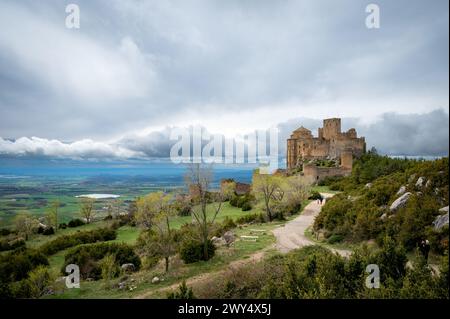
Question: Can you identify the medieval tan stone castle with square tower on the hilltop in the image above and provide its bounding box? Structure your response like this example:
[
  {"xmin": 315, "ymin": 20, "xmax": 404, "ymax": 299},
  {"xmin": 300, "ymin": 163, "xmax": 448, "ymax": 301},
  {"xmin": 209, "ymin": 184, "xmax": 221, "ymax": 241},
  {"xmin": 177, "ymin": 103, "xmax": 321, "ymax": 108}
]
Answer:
[{"xmin": 286, "ymin": 118, "xmax": 366, "ymax": 182}]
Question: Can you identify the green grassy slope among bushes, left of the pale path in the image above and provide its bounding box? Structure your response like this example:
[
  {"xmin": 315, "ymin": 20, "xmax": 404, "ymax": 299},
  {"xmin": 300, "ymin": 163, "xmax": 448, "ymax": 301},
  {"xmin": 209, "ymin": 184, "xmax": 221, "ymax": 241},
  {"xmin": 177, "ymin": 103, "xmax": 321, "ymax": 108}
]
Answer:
[{"xmin": 45, "ymin": 201, "xmax": 308, "ymax": 298}]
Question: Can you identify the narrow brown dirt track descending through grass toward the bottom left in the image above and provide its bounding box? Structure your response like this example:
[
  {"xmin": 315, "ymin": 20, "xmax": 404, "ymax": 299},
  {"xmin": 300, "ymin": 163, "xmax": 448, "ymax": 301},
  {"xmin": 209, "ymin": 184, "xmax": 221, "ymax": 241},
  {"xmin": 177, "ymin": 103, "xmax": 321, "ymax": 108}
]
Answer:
[{"xmin": 134, "ymin": 250, "xmax": 266, "ymax": 299}]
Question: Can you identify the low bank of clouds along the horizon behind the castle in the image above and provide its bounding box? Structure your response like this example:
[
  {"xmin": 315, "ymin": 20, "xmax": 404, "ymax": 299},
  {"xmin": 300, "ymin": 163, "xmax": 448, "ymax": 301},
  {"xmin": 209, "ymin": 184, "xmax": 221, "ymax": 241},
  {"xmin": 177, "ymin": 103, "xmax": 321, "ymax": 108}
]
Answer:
[{"xmin": 0, "ymin": 109, "xmax": 449, "ymax": 160}]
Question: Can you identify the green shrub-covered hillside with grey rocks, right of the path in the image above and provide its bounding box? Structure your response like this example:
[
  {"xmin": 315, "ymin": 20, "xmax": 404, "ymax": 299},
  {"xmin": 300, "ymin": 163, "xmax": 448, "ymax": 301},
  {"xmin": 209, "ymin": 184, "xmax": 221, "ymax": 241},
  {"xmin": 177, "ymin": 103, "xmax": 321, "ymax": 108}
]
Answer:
[{"xmin": 314, "ymin": 152, "xmax": 449, "ymax": 255}]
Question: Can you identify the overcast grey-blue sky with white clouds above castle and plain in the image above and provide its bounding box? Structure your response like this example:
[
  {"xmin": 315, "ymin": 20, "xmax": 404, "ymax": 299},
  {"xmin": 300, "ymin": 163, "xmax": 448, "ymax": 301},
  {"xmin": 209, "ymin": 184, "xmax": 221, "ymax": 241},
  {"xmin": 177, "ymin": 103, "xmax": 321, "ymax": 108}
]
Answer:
[{"xmin": 0, "ymin": 0, "xmax": 449, "ymax": 158}]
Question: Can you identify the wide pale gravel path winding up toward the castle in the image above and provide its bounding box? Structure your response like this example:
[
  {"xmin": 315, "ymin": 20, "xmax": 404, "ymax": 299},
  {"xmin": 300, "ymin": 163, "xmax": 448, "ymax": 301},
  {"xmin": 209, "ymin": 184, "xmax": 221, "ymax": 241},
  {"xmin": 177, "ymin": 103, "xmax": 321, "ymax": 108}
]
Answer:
[{"xmin": 272, "ymin": 193, "xmax": 351, "ymax": 257}]
